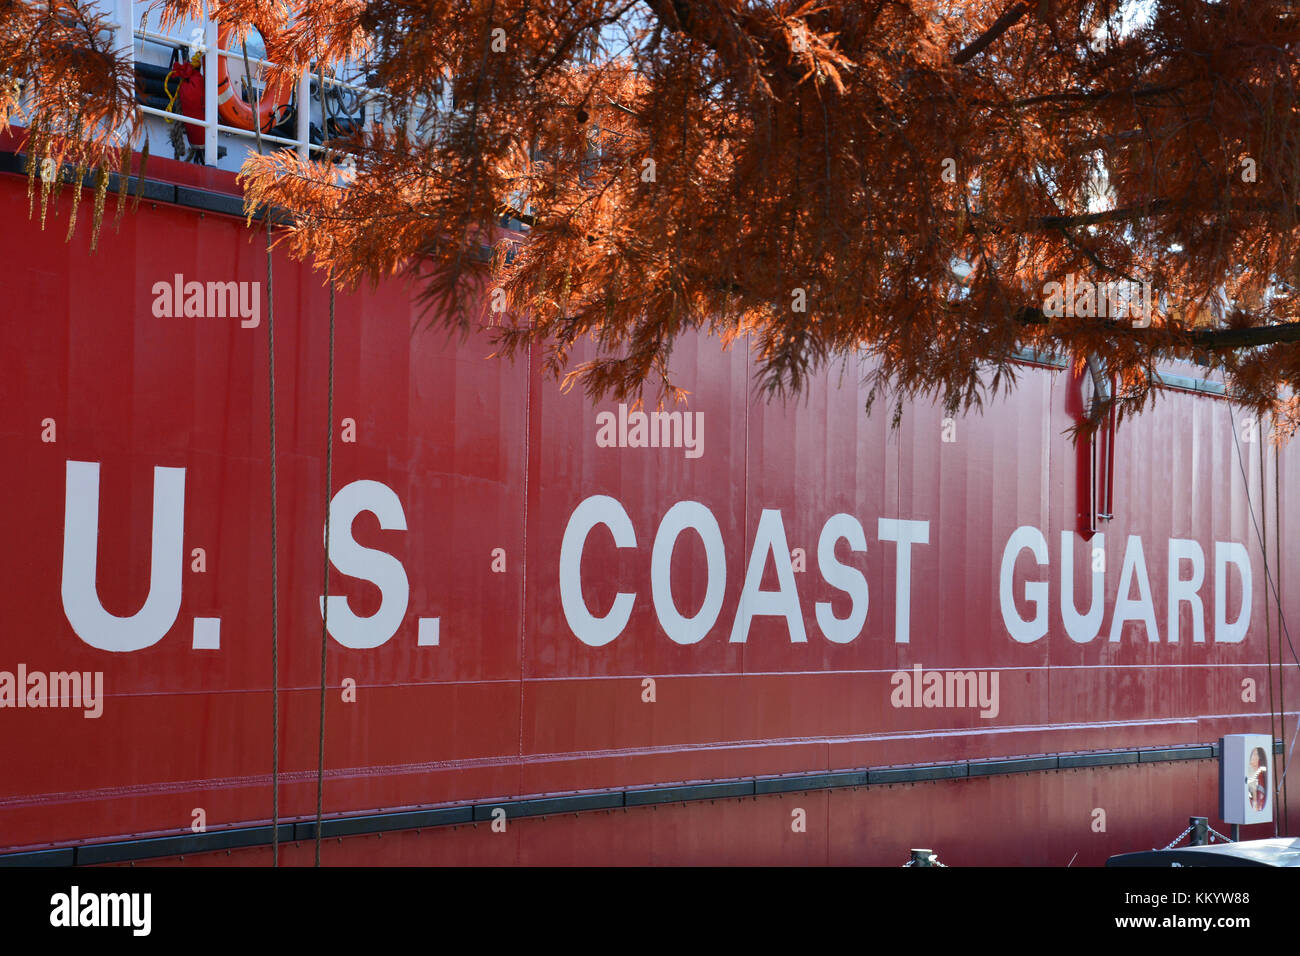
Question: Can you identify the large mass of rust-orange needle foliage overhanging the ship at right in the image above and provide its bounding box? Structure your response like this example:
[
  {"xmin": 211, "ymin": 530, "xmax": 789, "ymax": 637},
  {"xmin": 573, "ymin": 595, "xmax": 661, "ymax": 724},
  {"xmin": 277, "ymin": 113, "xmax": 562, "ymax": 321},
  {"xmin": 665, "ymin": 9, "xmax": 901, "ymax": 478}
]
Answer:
[{"xmin": 0, "ymin": 0, "xmax": 1300, "ymax": 426}]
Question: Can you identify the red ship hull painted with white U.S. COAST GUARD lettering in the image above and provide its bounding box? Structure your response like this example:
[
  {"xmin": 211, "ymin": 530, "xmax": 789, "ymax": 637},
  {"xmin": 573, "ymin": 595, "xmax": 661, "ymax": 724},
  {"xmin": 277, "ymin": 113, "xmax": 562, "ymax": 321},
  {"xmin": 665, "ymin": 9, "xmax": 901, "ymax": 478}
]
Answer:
[{"xmin": 0, "ymin": 151, "xmax": 1300, "ymax": 865}]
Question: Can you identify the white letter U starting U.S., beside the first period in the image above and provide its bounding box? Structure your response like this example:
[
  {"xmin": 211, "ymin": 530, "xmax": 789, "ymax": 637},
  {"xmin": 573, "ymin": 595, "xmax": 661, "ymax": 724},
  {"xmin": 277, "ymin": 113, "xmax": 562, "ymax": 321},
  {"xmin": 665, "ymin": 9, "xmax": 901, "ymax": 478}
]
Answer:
[{"xmin": 62, "ymin": 462, "xmax": 185, "ymax": 652}]
